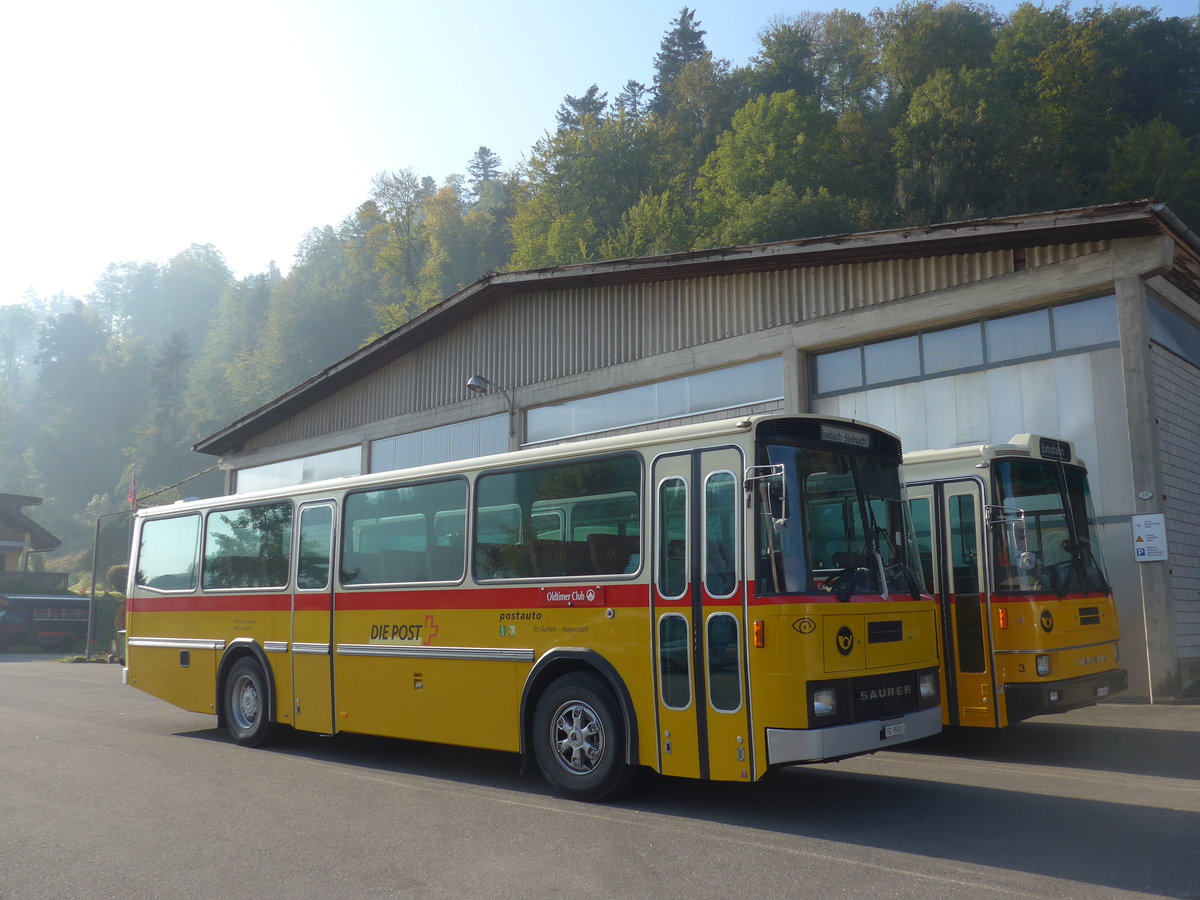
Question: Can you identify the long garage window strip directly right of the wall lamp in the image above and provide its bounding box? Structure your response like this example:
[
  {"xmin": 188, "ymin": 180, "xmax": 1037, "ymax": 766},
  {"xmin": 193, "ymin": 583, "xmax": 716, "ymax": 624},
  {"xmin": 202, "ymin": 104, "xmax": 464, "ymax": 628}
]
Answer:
[{"xmin": 526, "ymin": 356, "xmax": 784, "ymax": 444}]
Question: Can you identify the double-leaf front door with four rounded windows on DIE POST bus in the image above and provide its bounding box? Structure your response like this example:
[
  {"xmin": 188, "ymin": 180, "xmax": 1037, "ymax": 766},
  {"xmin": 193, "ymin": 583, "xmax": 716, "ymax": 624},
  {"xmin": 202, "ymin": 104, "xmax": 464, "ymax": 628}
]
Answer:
[{"xmin": 652, "ymin": 449, "xmax": 752, "ymax": 780}]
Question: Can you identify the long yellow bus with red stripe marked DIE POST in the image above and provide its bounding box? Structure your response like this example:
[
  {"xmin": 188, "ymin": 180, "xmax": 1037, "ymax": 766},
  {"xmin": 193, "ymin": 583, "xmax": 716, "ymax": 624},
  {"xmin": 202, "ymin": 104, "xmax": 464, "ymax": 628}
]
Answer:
[{"xmin": 125, "ymin": 416, "xmax": 942, "ymax": 799}]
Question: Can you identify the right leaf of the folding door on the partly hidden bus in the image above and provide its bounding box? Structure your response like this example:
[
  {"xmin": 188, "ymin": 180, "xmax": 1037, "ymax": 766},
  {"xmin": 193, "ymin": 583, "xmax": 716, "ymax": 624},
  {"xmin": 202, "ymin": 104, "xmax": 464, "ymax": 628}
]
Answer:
[{"xmin": 942, "ymin": 481, "xmax": 1000, "ymax": 726}]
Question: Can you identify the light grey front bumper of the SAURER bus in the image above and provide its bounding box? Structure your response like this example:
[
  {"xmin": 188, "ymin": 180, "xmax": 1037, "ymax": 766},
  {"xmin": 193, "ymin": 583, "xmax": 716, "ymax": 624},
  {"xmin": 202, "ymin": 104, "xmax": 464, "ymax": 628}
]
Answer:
[{"xmin": 767, "ymin": 707, "xmax": 942, "ymax": 766}]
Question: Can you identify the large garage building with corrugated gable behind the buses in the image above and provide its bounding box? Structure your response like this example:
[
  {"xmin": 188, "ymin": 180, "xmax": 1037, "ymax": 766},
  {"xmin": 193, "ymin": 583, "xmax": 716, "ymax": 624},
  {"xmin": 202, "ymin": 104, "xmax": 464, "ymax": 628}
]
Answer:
[{"xmin": 194, "ymin": 200, "xmax": 1200, "ymax": 701}]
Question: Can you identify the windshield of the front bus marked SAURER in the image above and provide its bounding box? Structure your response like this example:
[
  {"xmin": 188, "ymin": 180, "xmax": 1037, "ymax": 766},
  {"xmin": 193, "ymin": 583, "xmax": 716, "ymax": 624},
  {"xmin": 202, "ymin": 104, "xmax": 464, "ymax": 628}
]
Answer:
[{"xmin": 756, "ymin": 444, "xmax": 924, "ymax": 601}]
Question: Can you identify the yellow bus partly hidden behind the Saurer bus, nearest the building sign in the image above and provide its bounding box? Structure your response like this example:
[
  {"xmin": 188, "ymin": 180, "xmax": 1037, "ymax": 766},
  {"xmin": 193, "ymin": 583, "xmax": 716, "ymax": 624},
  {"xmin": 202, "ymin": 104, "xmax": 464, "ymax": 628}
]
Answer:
[{"xmin": 904, "ymin": 434, "xmax": 1128, "ymax": 728}]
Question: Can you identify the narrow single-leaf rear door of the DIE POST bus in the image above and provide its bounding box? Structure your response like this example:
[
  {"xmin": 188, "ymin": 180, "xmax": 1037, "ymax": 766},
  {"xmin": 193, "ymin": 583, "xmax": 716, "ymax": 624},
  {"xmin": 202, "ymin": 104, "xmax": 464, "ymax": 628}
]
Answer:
[{"xmin": 280, "ymin": 503, "xmax": 335, "ymax": 734}]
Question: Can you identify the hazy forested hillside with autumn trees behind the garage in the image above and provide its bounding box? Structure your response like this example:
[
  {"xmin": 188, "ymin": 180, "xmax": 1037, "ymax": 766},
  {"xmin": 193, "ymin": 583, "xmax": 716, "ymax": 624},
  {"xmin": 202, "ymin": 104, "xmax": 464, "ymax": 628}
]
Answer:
[{"xmin": 0, "ymin": 0, "xmax": 1200, "ymax": 571}]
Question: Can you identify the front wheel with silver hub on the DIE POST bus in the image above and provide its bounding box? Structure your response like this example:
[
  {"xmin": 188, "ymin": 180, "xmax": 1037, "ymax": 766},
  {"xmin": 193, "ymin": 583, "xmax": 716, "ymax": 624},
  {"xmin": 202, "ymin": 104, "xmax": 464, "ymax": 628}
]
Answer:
[{"xmin": 532, "ymin": 672, "xmax": 634, "ymax": 800}]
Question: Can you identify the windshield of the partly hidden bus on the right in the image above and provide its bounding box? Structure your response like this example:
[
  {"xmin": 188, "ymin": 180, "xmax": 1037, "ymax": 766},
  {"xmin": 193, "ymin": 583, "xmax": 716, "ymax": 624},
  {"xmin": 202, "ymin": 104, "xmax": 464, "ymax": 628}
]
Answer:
[{"xmin": 988, "ymin": 460, "xmax": 1109, "ymax": 595}]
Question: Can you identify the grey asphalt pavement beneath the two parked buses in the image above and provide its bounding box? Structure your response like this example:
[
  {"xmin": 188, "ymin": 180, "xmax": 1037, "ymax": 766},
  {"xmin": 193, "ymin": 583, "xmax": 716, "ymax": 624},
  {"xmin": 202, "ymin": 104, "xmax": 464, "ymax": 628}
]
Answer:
[{"xmin": 0, "ymin": 654, "xmax": 1200, "ymax": 900}]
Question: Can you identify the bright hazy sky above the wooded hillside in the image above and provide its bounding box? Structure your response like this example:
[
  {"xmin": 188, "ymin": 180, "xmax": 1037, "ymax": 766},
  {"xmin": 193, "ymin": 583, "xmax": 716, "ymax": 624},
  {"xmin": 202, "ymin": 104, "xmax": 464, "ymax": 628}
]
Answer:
[{"xmin": 0, "ymin": 0, "xmax": 1196, "ymax": 304}]
